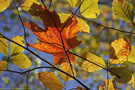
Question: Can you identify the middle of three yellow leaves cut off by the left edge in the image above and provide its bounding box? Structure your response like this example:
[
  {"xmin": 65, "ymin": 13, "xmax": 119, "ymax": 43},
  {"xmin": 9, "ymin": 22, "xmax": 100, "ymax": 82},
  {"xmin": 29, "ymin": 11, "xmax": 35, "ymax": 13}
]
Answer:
[{"xmin": 0, "ymin": 36, "xmax": 9, "ymax": 56}]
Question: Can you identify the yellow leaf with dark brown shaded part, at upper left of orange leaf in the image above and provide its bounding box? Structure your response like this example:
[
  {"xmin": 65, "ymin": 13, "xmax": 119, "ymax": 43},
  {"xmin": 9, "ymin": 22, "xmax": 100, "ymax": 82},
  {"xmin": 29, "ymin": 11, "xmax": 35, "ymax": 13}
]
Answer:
[{"xmin": 21, "ymin": 0, "xmax": 42, "ymax": 16}]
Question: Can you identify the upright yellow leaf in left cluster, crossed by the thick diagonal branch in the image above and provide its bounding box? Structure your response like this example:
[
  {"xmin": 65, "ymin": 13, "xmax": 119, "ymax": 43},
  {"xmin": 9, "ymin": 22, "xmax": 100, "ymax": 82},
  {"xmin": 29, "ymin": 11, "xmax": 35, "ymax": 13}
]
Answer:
[{"xmin": 10, "ymin": 36, "xmax": 25, "ymax": 56}]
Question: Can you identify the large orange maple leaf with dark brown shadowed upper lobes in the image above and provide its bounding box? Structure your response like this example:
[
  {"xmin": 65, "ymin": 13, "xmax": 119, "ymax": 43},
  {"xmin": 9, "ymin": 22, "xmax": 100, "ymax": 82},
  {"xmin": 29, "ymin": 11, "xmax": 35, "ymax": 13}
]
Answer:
[{"xmin": 23, "ymin": 3, "xmax": 81, "ymax": 65}]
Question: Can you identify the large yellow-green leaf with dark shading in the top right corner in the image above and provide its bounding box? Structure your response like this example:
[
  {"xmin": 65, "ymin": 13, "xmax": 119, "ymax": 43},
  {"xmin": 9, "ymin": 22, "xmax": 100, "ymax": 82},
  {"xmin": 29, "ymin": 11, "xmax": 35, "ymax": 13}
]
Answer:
[{"xmin": 112, "ymin": 0, "xmax": 134, "ymax": 22}]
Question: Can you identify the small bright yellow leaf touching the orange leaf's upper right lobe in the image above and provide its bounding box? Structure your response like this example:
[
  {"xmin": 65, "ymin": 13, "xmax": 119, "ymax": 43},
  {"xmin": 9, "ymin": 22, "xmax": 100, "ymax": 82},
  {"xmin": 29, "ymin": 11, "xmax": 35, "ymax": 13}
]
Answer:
[{"xmin": 77, "ymin": 17, "xmax": 90, "ymax": 33}]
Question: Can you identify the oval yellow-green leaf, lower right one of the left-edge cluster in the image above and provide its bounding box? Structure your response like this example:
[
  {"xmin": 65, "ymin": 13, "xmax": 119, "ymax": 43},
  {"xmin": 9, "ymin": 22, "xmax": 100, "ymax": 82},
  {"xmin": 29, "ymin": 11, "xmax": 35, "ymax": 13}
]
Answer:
[{"xmin": 11, "ymin": 54, "xmax": 32, "ymax": 69}]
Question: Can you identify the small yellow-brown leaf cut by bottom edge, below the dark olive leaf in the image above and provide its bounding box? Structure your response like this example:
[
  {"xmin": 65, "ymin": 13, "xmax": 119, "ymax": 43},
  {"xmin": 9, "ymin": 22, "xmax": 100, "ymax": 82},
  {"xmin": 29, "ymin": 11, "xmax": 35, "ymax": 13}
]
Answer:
[{"xmin": 104, "ymin": 79, "xmax": 117, "ymax": 90}]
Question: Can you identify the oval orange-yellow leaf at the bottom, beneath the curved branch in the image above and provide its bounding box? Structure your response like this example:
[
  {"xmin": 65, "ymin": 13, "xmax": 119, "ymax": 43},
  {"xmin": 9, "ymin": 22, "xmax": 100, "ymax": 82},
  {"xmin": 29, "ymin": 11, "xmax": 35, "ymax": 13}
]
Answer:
[{"xmin": 38, "ymin": 71, "xmax": 63, "ymax": 90}]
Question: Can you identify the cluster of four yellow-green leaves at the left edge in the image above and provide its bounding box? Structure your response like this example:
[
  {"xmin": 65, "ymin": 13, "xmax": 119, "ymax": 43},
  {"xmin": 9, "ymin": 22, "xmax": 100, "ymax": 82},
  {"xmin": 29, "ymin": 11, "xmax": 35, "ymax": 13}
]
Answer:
[{"xmin": 0, "ymin": 36, "xmax": 32, "ymax": 73}]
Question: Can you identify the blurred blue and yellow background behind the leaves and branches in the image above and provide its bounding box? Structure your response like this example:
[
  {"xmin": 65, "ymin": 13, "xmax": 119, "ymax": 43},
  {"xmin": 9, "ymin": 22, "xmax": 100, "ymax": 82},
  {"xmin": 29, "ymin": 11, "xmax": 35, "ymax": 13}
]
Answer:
[{"xmin": 0, "ymin": 0, "xmax": 135, "ymax": 90}]
